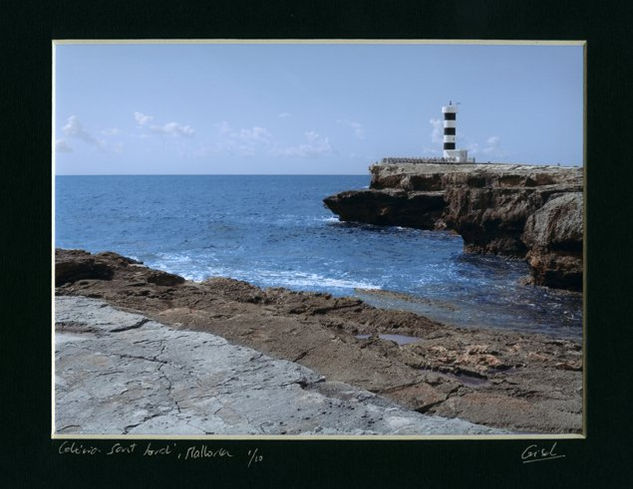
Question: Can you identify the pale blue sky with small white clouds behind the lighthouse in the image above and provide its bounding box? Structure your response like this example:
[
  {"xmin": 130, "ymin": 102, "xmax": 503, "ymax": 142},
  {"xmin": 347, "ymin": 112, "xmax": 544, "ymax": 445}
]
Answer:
[{"xmin": 54, "ymin": 43, "xmax": 583, "ymax": 175}]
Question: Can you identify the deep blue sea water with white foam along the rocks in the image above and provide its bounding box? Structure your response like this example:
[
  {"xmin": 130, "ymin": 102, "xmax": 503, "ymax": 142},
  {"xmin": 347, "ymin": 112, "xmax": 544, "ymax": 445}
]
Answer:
[{"xmin": 55, "ymin": 176, "xmax": 582, "ymax": 337}]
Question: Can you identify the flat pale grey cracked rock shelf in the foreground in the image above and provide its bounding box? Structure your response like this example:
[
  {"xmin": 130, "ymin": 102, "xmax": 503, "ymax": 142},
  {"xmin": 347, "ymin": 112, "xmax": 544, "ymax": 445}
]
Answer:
[{"xmin": 55, "ymin": 297, "xmax": 504, "ymax": 435}]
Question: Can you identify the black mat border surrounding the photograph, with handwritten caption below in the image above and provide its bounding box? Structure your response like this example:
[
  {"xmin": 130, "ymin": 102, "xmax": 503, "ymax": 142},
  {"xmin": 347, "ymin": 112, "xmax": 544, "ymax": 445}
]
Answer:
[{"xmin": 0, "ymin": 1, "xmax": 633, "ymax": 488}]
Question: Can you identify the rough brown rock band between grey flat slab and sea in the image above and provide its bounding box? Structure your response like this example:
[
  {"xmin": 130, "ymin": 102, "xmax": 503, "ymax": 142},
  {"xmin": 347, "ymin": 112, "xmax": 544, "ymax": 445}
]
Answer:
[{"xmin": 55, "ymin": 250, "xmax": 583, "ymax": 433}]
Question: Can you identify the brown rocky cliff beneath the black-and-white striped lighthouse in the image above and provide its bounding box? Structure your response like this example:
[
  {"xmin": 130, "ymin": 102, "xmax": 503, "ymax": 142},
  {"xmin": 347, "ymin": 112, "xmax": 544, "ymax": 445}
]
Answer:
[{"xmin": 324, "ymin": 163, "xmax": 583, "ymax": 290}]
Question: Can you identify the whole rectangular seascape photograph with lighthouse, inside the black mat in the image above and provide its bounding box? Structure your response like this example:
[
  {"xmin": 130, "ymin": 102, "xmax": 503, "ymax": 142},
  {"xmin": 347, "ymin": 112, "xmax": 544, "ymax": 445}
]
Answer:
[{"xmin": 51, "ymin": 40, "xmax": 585, "ymax": 439}]
